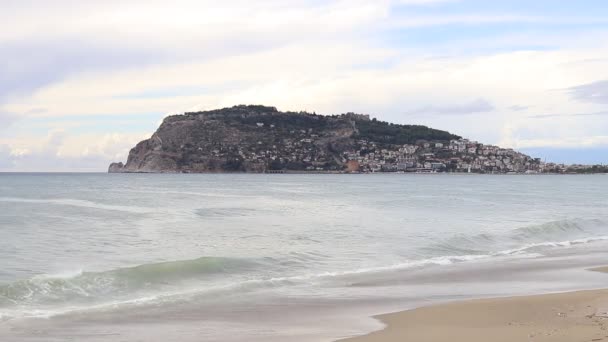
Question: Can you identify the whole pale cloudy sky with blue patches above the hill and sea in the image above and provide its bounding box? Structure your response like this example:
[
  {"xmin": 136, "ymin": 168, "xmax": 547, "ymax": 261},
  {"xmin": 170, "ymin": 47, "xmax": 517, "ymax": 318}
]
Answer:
[{"xmin": 0, "ymin": 0, "xmax": 608, "ymax": 172}]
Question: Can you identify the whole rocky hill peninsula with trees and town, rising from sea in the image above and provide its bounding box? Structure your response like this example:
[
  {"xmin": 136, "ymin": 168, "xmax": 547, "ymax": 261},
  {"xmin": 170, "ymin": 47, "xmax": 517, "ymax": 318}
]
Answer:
[{"xmin": 108, "ymin": 105, "xmax": 544, "ymax": 173}]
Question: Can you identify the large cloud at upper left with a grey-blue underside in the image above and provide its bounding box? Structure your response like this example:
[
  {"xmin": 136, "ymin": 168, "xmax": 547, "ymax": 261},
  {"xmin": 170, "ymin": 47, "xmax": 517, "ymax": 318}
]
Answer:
[{"xmin": 0, "ymin": 0, "xmax": 390, "ymax": 111}]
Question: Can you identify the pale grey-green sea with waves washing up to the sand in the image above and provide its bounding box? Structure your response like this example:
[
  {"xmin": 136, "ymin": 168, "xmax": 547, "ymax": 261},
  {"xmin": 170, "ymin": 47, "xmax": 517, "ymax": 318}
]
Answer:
[{"xmin": 0, "ymin": 173, "xmax": 608, "ymax": 342}]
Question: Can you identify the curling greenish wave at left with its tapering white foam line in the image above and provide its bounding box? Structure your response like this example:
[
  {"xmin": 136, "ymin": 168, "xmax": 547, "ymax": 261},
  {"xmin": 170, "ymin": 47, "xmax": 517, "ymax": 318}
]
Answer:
[{"xmin": 0, "ymin": 255, "xmax": 489, "ymax": 321}]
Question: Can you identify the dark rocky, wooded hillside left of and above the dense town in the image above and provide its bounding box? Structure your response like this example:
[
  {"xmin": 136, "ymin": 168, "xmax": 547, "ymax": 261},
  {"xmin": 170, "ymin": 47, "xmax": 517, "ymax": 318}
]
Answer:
[{"xmin": 108, "ymin": 106, "xmax": 459, "ymax": 173}]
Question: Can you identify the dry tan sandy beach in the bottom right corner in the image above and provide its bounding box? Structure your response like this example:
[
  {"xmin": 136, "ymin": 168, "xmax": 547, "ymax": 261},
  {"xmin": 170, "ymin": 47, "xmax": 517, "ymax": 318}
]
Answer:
[{"xmin": 342, "ymin": 267, "xmax": 608, "ymax": 342}]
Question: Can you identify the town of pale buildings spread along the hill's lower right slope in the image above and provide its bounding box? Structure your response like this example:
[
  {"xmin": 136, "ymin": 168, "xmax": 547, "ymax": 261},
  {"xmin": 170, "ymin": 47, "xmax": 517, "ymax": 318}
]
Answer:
[{"xmin": 228, "ymin": 122, "xmax": 608, "ymax": 174}]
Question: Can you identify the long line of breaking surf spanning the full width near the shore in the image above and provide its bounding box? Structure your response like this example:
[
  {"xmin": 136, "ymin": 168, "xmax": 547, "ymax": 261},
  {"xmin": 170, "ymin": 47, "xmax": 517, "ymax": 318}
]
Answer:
[{"xmin": 0, "ymin": 219, "xmax": 608, "ymax": 320}]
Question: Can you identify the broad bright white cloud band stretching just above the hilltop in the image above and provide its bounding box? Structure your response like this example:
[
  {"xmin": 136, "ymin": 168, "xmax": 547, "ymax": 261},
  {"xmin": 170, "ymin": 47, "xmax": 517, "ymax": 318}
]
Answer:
[{"xmin": 8, "ymin": 43, "xmax": 608, "ymax": 154}]
